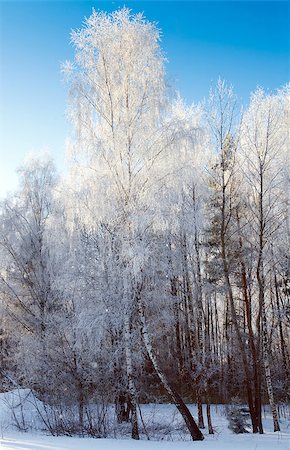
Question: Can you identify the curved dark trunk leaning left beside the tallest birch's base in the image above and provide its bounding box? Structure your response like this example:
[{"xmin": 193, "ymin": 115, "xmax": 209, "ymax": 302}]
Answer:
[{"xmin": 137, "ymin": 294, "xmax": 204, "ymax": 441}]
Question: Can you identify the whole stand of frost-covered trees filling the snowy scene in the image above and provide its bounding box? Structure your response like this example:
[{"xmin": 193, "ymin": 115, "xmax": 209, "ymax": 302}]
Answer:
[{"xmin": 0, "ymin": 8, "xmax": 290, "ymax": 440}]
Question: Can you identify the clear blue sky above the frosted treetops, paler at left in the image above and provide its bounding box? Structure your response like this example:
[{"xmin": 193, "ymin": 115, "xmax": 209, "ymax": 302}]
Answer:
[{"xmin": 0, "ymin": 0, "xmax": 289, "ymax": 197}]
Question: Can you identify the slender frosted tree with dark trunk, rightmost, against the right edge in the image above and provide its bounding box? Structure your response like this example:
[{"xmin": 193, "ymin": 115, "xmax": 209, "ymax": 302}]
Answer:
[{"xmin": 240, "ymin": 89, "xmax": 288, "ymax": 431}]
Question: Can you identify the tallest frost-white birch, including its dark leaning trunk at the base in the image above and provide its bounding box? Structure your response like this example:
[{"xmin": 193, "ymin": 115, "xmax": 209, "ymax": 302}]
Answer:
[{"xmin": 62, "ymin": 8, "xmax": 202, "ymax": 439}]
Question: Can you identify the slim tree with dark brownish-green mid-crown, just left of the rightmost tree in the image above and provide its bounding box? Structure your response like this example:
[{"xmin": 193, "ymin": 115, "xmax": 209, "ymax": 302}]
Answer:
[{"xmin": 204, "ymin": 80, "xmax": 262, "ymax": 432}]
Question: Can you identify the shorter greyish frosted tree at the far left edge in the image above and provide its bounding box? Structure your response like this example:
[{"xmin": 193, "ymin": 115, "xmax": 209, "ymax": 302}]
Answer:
[{"xmin": 0, "ymin": 158, "xmax": 57, "ymax": 391}]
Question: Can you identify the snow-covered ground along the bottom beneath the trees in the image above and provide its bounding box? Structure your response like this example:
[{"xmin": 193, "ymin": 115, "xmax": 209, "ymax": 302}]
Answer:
[{"xmin": 0, "ymin": 391, "xmax": 290, "ymax": 450}]
